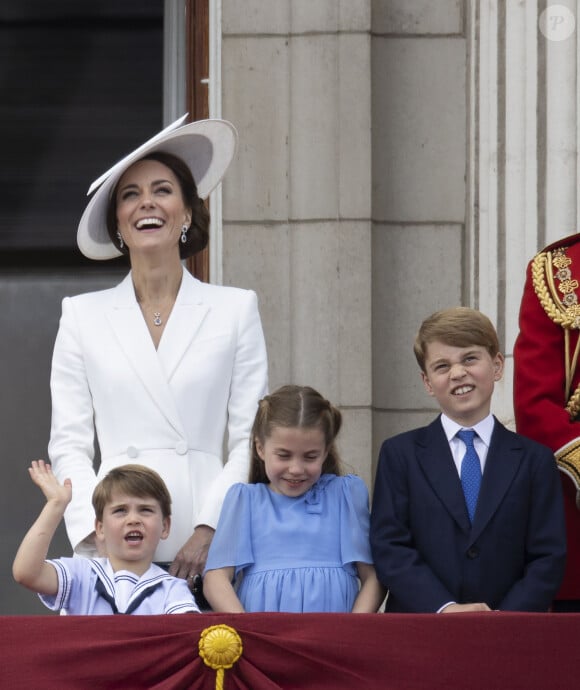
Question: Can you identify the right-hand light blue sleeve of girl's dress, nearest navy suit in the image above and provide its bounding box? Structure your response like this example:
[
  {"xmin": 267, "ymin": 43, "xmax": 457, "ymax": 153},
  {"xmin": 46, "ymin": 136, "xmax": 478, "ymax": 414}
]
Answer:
[{"xmin": 339, "ymin": 474, "xmax": 373, "ymax": 565}]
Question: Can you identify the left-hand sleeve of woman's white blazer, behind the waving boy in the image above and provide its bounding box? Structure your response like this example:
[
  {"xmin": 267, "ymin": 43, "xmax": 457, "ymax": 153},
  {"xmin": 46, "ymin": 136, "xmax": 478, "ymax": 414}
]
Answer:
[{"xmin": 48, "ymin": 297, "xmax": 96, "ymax": 555}]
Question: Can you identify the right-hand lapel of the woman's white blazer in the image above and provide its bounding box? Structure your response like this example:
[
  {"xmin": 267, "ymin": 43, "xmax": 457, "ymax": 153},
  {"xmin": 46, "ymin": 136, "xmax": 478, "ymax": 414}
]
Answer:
[{"xmin": 157, "ymin": 269, "xmax": 209, "ymax": 381}]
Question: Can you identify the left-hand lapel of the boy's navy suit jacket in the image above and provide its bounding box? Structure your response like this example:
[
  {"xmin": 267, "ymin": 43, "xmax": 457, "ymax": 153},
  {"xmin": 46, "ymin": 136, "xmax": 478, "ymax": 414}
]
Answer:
[{"xmin": 416, "ymin": 417, "xmax": 471, "ymax": 532}]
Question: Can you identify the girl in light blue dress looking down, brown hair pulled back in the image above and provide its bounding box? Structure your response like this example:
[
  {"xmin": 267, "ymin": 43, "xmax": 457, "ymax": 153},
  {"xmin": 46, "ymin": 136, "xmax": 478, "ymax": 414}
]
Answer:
[{"xmin": 204, "ymin": 386, "xmax": 384, "ymax": 613}]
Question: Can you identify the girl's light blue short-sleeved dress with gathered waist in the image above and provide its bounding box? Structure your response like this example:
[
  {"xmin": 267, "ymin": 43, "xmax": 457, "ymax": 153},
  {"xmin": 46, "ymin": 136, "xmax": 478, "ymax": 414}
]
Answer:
[{"xmin": 206, "ymin": 474, "xmax": 372, "ymax": 613}]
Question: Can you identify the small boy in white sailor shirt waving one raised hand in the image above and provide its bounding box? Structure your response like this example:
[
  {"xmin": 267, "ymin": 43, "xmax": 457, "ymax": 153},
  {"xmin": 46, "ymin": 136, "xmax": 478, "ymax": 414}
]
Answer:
[{"xmin": 12, "ymin": 460, "xmax": 199, "ymax": 615}]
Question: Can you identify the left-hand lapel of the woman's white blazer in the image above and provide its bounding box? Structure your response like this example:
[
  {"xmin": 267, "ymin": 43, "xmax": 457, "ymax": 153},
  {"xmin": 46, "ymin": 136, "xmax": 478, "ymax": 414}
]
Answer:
[{"xmin": 106, "ymin": 273, "xmax": 184, "ymax": 435}]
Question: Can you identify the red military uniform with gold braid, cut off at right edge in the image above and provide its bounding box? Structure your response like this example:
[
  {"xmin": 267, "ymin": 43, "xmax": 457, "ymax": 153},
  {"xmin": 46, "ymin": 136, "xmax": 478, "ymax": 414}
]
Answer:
[{"xmin": 514, "ymin": 234, "xmax": 580, "ymax": 600}]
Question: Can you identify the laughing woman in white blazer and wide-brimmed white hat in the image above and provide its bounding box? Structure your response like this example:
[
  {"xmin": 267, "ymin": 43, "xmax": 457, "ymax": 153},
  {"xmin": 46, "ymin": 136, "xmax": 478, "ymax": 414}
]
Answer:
[{"xmin": 49, "ymin": 118, "xmax": 267, "ymax": 592}]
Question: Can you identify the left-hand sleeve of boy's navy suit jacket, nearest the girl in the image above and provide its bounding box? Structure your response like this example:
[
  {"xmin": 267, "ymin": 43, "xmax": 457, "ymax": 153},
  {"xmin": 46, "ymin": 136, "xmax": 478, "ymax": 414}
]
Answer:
[{"xmin": 370, "ymin": 439, "xmax": 455, "ymax": 613}]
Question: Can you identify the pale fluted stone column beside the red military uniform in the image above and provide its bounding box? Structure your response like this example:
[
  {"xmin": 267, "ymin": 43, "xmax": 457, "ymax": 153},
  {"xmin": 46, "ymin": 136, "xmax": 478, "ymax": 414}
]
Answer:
[{"xmin": 466, "ymin": 0, "xmax": 578, "ymax": 425}]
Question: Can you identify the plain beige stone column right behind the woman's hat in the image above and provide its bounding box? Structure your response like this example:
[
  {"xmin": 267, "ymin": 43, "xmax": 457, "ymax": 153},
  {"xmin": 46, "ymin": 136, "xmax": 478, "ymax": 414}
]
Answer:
[{"xmin": 222, "ymin": 0, "xmax": 372, "ymax": 484}]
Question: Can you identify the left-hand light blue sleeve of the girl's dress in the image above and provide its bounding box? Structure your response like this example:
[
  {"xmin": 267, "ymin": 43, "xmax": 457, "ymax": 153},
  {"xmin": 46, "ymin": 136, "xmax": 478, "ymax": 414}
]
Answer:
[{"xmin": 205, "ymin": 484, "xmax": 258, "ymax": 576}]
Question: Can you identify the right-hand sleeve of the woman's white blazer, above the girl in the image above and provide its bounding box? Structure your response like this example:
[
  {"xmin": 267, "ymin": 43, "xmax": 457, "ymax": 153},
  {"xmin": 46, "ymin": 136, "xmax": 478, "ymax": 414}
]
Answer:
[{"xmin": 198, "ymin": 290, "xmax": 268, "ymax": 528}]
